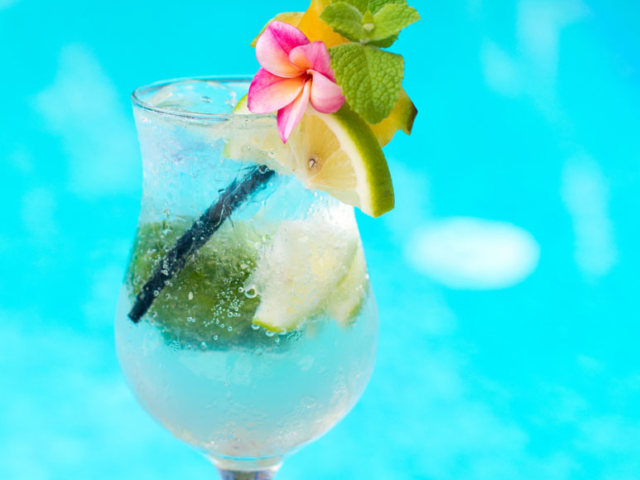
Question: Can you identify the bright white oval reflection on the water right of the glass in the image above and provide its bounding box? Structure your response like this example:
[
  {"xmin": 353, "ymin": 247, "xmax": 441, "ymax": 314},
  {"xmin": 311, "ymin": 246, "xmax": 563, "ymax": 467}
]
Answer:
[{"xmin": 405, "ymin": 217, "xmax": 540, "ymax": 290}]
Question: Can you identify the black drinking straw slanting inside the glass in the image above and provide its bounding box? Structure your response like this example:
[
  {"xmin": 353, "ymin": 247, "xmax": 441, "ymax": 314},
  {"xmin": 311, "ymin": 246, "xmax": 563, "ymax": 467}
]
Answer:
[{"xmin": 129, "ymin": 166, "xmax": 275, "ymax": 323}]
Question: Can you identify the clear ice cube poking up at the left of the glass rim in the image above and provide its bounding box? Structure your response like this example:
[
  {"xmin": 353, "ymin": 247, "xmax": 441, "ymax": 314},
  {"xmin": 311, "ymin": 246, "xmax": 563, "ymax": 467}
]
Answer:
[{"xmin": 148, "ymin": 80, "xmax": 238, "ymax": 114}]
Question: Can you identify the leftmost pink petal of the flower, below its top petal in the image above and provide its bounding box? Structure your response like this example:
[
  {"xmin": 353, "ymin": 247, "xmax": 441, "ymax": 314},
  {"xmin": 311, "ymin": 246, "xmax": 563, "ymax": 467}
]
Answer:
[{"xmin": 247, "ymin": 68, "xmax": 304, "ymax": 113}]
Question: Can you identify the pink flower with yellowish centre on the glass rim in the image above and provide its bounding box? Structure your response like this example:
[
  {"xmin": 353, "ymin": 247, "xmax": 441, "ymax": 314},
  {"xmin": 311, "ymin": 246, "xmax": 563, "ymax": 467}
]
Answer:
[{"xmin": 248, "ymin": 21, "xmax": 345, "ymax": 143}]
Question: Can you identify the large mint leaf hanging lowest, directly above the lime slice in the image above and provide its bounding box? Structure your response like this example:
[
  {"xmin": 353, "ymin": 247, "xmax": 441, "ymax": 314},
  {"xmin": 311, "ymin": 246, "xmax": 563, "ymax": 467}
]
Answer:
[{"xmin": 329, "ymin": 43, "xmax": 404, "ymax": 125}]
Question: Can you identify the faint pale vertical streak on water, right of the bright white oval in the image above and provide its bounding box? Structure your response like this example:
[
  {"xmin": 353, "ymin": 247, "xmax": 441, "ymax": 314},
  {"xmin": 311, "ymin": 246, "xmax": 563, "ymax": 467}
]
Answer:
[{"xmin": 562, "ymin": 156, "xmax": 618, "ymax": 280}]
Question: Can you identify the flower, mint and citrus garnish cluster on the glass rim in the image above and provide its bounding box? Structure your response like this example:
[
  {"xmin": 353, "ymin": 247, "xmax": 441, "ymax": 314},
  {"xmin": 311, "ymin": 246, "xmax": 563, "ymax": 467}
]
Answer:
[{"xmin": 248, "ymin": 0, "xmax": 420, "ymax": 216}]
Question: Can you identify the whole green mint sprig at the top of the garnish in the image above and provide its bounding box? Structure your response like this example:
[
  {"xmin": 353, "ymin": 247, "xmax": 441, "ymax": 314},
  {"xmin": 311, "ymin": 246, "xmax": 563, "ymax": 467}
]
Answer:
[{"xmin": 320, "ymin": 0, "xmax": 420, "ymax": 125}]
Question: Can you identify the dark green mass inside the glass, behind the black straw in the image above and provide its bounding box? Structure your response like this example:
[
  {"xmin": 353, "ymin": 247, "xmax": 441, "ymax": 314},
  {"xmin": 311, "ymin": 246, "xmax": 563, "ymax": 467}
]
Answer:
[{"xmin": 127, "ymin": 220, "xmax": 273, "ymax": 348}]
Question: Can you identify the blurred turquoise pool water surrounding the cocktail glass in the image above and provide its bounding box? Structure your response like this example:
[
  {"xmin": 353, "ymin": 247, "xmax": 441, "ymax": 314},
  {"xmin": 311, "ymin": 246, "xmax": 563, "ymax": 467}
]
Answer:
[{"xmin": 0, "ymin": 0, "xmax": 640, "ymax": 480}]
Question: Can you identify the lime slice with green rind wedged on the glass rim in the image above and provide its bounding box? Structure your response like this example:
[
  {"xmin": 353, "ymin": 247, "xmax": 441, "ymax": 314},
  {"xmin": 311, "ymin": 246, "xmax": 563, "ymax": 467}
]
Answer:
[{"xmin": 225, "ymin": 96, "xmax": 394, "ymax": 217}]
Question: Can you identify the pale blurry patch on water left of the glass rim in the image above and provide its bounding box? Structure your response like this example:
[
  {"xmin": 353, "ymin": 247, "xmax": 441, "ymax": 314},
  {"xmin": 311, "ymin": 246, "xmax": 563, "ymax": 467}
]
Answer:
[{"xmin": 33, "ymin": 43, "xmax": 140, "ymax": 198}]
